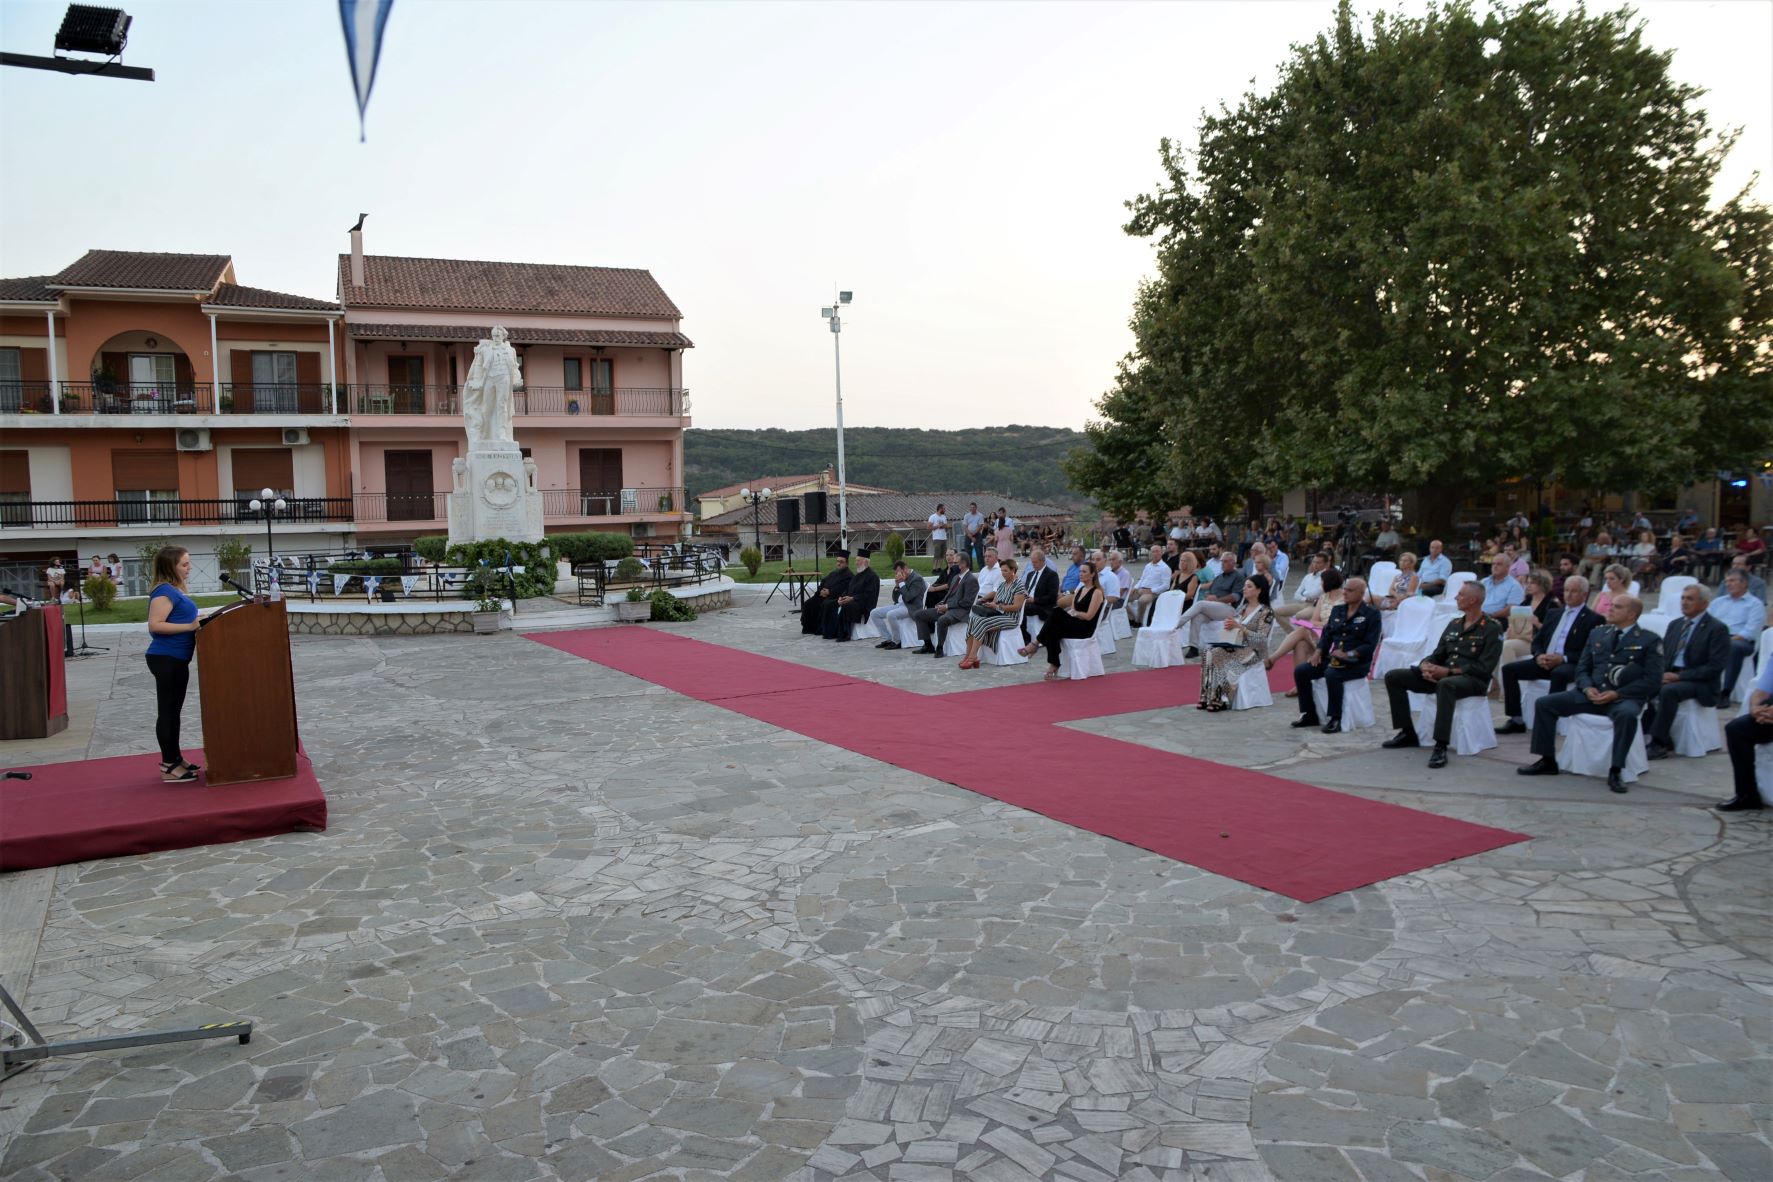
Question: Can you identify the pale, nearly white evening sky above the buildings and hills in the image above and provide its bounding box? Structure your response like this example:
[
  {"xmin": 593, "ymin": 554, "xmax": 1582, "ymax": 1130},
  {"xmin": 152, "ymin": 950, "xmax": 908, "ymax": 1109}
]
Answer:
[{"xmin": 0, "ymin": 0, "xmax": 1773, "ymax": 427}]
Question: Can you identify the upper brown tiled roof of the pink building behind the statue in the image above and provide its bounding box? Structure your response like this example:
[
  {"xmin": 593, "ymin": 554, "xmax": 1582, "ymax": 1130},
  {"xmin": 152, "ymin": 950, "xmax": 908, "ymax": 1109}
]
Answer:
[{"xmin": 339, "ymin": 255, "xmax": 683, "ymax": 319}]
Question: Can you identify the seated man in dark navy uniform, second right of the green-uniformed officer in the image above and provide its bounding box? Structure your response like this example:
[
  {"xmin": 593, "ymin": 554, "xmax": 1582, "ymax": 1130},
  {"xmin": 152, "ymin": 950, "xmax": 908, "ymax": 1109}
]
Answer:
[{"xmin": 1516, "ymin": 595, "xmax": 1661, "ymax": 792}]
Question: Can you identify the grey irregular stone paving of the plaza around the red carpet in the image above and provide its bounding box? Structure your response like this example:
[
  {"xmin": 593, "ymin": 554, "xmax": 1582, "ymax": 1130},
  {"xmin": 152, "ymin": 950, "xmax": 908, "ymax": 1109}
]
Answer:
[{"xmin": 0, "ymin": 595, "xmax": 1773, "ymax": 1182}]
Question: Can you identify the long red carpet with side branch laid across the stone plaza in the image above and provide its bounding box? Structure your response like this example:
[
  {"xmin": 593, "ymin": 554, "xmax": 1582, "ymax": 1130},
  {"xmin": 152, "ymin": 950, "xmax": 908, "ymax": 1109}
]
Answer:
[{"xmin": 530, "ymin": 627, "xmax": 1527, "ymax": 902}]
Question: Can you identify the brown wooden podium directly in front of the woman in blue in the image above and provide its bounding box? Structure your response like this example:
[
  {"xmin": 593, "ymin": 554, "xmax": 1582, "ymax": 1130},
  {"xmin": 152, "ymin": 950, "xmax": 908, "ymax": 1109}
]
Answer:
[{"xmin": 197, "ymin": 601, "xmax": 296, "ymax": 787}]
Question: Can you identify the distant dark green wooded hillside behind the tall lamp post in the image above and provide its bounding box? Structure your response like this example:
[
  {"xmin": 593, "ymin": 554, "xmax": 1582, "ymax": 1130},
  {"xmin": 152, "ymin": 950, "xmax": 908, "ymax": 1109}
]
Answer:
[{"xmin": 683, "ymin": 425, "xmax": 1089, "ymax": 509}]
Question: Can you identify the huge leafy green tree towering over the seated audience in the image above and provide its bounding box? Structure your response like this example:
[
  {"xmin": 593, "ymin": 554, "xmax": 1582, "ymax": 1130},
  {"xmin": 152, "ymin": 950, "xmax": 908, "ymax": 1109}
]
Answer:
[{"xmin": 1069, "ymin": 0, "xmax": 1773, "ymax": 530}]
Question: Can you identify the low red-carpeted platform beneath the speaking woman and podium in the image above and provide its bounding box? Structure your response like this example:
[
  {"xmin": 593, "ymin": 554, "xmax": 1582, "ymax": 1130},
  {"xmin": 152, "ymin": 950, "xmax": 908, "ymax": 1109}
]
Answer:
[{"xmin": 0, "ymin": 751, "xmax": 326, "ymax": 870}]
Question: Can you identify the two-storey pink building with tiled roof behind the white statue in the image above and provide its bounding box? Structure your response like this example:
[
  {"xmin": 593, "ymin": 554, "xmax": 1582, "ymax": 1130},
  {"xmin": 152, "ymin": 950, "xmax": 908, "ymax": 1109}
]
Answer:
[{"xmin": 339, "ymin": 232, "xmax": 693, "ymax": 542}]
